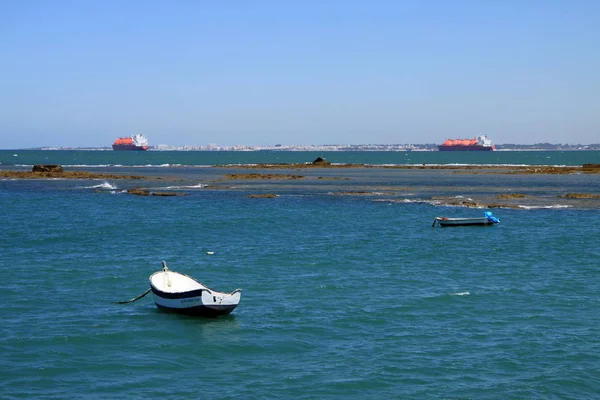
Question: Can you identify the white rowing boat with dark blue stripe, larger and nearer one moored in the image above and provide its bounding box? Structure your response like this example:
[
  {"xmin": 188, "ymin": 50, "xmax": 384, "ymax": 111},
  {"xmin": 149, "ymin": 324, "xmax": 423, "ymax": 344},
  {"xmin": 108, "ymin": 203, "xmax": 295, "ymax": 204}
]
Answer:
[{"xmin": 150, "ymin": 261, "xmax": 242, "ymax": 317}]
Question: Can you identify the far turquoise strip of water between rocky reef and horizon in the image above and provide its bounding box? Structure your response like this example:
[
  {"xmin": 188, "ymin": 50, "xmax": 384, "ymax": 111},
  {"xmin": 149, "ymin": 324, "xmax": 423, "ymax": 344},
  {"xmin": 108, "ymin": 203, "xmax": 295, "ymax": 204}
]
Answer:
[{"xmin": 0, "ymin": 150, "xmax": 600, "ymax": 168}]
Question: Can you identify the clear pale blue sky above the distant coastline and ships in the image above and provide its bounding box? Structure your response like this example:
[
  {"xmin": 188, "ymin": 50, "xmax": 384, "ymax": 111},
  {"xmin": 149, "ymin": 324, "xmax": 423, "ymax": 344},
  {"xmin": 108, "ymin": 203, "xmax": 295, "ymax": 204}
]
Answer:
[{"xmin": 0, "ymin": 0, "xmax": 600, "ymax": 149}]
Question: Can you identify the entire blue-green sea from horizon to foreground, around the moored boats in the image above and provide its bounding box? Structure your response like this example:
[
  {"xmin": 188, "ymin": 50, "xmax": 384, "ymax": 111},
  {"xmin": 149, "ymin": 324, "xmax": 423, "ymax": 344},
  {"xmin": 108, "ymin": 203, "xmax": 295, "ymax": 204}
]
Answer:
[{"xmin": 0, "ymin": 150, "xmax": 600, "ymax": 400}]
